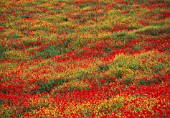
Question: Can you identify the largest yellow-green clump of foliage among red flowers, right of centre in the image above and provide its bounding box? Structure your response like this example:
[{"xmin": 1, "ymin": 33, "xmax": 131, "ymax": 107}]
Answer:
[{"xmin": 105, "ymin": 51, "xmax": 169, "ymax": 85}]
